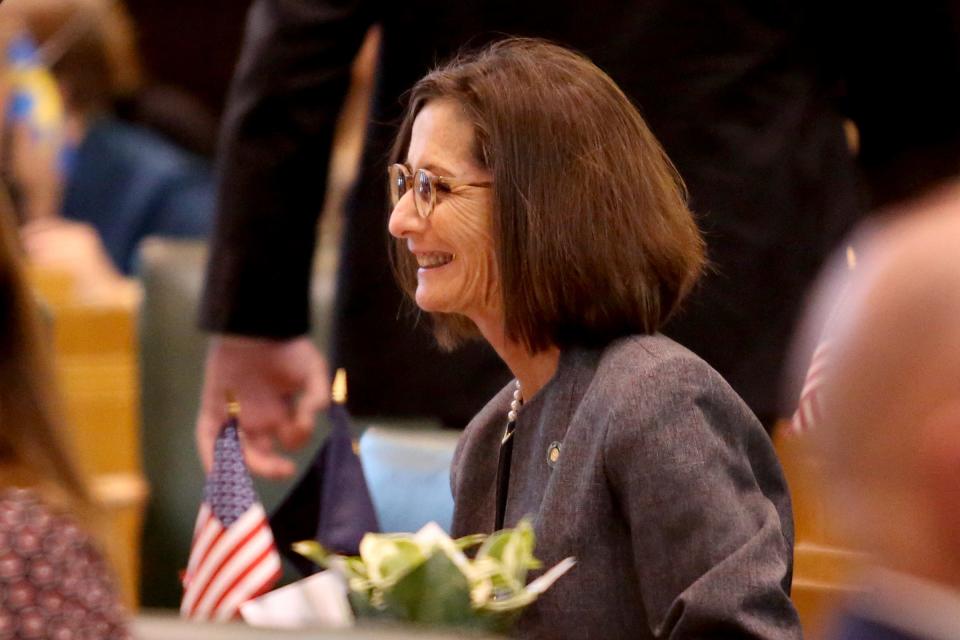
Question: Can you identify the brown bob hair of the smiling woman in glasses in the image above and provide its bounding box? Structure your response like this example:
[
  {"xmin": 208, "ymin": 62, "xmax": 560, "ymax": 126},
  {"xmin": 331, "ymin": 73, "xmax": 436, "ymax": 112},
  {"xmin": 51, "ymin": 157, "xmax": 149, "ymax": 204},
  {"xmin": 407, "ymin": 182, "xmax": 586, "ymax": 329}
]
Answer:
[{"xmin": 392, "ymin": 38, "xmax": 704, "ymax": 352}]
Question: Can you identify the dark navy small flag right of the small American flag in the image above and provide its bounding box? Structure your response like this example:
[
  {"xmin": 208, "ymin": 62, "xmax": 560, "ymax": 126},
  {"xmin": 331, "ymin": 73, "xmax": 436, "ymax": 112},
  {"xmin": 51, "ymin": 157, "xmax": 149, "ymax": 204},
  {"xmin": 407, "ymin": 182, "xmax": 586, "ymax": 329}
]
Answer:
[{"xmin": 270, "ymin": 404, "xmax": 380, "ymax": 576}]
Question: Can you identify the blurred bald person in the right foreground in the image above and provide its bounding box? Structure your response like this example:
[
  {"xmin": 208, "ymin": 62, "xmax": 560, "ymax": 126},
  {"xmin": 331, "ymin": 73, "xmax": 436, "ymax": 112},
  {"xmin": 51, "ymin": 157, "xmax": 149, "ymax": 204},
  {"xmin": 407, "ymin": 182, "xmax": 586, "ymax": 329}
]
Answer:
[{"xmin": 810, "ymin": 181, "xmax": 960, "ymax": 640}]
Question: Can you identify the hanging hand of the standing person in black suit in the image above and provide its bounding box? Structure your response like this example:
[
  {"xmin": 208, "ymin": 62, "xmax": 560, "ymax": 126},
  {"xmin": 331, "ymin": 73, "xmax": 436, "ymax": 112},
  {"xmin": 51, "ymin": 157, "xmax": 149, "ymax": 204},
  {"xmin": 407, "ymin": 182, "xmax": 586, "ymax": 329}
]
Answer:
[{"xmin": 197, "ymin": 336, "xmax": 330, "ymax": 479}]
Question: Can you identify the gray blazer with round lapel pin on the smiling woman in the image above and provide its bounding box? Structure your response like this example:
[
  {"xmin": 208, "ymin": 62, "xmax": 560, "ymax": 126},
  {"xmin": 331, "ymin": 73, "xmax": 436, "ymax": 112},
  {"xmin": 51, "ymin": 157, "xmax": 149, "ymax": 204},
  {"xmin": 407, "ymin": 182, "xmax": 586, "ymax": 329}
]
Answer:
[{"xmin": 451, "ymin": 335, "xmax": 801, "ymax": 639}]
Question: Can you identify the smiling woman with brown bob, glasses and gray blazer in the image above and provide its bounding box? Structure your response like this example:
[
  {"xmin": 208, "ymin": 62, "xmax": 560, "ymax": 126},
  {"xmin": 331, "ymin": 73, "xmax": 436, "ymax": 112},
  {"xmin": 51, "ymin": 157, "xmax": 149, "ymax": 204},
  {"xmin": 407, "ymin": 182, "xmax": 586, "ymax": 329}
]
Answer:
[{"xmin": 389, "ymin": 39, "xmax": 800, "ymax": 638}]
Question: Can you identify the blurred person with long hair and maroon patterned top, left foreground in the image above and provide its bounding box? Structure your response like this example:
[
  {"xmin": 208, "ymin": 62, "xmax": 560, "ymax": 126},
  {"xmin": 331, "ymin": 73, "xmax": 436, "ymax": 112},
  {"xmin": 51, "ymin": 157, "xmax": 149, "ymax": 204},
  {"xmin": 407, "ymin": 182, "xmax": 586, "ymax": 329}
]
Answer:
[{"xmin": 0, "ymin": 185, "xmax": 130, "ymax": 639}]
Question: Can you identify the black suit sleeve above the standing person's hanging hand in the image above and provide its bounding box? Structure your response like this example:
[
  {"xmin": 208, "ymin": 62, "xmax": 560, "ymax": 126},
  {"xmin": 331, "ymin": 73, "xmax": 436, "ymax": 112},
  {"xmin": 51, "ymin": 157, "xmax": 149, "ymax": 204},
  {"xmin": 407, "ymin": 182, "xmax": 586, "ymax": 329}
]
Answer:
[{"xmin": 200, "ymin": 0, "xmax": 373, "ymax": 338}]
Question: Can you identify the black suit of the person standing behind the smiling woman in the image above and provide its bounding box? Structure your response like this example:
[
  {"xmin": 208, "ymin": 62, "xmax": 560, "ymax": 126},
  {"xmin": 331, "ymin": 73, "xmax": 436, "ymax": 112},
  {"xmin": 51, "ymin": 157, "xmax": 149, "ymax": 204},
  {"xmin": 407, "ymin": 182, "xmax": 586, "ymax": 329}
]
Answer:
[{"xmin": 202, "ymin": 0, "xmax": 960, "ymax": 425}]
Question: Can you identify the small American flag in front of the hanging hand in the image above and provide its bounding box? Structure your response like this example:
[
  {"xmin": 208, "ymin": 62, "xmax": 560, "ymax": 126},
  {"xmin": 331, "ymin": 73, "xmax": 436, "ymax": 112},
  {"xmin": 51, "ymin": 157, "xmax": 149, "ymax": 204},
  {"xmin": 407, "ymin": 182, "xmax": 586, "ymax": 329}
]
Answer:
[{"xmin": 180, "ymin": 417, "xmax": 281, "ymax": 620}]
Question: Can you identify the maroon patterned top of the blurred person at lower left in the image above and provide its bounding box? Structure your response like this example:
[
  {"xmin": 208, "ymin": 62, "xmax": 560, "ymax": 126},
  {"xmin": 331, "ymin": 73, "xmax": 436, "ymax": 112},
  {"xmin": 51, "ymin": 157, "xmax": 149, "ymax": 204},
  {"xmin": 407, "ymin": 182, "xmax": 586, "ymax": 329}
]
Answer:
[{"xmin": 0, "ymin": 489, "xmax": 130, "ymax": 640}]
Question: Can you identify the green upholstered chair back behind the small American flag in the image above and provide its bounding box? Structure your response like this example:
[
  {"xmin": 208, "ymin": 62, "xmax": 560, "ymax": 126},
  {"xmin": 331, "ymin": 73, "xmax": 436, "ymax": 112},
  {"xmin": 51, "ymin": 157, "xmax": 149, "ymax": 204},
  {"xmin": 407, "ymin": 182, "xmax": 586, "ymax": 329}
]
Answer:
[{"xmin": 138, "ymin": 238, "xmax": 332, "ymax": 608}]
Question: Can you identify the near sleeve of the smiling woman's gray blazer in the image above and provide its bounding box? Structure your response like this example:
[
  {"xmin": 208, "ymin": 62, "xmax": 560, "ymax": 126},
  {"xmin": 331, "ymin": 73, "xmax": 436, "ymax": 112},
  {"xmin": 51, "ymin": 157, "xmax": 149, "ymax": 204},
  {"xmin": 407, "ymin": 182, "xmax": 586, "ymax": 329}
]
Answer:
[{"xmin": 604, "ymin": 361, "xmax": 800, "ymax": 639}]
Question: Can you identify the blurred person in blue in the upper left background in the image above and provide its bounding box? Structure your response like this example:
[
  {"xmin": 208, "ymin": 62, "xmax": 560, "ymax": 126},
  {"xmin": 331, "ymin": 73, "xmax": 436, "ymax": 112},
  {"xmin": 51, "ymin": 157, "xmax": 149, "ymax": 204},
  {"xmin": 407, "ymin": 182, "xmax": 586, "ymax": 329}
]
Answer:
[{"xmin": 0, "ymin": 0, "xmax": 213, "ymax": 290}]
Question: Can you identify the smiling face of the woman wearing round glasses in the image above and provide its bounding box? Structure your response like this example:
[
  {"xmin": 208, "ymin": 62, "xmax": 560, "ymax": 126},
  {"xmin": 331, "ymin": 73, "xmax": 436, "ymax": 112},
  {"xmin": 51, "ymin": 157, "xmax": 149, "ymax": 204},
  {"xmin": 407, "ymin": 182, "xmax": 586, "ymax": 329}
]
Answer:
[{"xmin": 389, "ymin": 99, "xmax": 501, "ymax": 324}]
